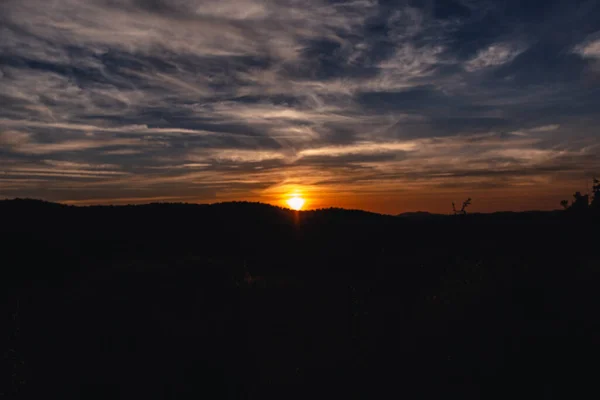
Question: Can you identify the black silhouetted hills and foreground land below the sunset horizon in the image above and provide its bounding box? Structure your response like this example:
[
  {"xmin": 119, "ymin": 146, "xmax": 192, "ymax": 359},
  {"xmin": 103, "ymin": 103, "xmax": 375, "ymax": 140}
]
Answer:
[{"xmin": 0, "ymin": 201, "xmax": 600, "ymax": 399}]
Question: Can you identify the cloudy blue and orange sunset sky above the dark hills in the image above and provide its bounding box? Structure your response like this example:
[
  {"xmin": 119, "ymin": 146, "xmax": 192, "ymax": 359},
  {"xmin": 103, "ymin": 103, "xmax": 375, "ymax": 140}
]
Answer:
[{"xmin": 0, "ymin": 0, "xmax": 600, "ymax": 214}]
